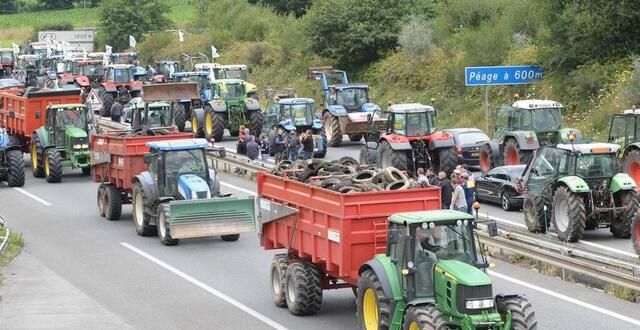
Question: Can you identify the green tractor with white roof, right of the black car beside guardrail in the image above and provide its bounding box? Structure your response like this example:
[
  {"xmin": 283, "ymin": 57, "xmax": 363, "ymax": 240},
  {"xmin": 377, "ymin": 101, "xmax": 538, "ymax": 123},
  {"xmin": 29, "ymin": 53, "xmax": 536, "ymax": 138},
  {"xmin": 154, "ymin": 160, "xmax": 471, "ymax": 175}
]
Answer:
[{"xmin": 523, "ymin": 143, "xmax": 640, "ymax": 242}]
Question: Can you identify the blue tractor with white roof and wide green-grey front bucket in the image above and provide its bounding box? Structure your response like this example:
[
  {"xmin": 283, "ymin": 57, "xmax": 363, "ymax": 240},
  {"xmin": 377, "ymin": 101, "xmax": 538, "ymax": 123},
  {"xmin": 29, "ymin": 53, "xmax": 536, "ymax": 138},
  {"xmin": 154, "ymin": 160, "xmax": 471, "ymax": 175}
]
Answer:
[{"xmin": 131, "ymin": 139, "xmax": 257, "ymax": 245}]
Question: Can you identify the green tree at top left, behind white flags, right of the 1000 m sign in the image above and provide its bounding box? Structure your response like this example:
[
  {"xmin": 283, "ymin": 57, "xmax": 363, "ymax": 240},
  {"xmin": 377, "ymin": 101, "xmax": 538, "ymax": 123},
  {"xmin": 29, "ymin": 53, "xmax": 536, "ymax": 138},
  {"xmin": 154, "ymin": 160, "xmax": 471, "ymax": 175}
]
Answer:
[{"xmin": 98, "ymin": 0, "xmax": 172, "ymax": 51}]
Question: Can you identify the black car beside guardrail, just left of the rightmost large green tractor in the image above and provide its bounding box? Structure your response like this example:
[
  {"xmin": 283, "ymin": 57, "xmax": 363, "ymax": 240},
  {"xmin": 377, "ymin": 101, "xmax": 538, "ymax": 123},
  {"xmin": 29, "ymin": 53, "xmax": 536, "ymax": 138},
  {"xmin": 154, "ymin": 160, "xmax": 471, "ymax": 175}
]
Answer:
[{"xmin": 476, "ymin": 165, "xmax": 527, "ymax": 211}]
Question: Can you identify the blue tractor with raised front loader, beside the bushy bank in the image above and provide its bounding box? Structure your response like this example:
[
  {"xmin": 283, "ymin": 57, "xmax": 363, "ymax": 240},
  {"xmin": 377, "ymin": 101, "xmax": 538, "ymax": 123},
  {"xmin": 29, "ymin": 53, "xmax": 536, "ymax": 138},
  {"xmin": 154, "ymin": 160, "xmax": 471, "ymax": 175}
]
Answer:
[{"xmin": 309, "ymin": 67, "xmax": 385, "ymax": 147}]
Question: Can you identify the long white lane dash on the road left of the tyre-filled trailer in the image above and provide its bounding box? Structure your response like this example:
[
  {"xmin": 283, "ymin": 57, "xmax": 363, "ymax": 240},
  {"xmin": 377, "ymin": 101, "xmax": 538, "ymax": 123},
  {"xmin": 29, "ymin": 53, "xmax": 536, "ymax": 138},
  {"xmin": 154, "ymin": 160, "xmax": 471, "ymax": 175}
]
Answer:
[{"xmin": 120, "ymin": 242, "xmax": 287, "ymax": 330}]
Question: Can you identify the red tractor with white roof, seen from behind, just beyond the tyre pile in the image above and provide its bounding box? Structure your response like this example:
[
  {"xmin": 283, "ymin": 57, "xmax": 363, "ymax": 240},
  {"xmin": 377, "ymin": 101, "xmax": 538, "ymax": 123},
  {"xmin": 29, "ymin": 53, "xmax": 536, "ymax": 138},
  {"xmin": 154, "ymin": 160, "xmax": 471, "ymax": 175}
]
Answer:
[{"xmin": 360, "ymin": 103, "xmax": 458, "ymax": 176}]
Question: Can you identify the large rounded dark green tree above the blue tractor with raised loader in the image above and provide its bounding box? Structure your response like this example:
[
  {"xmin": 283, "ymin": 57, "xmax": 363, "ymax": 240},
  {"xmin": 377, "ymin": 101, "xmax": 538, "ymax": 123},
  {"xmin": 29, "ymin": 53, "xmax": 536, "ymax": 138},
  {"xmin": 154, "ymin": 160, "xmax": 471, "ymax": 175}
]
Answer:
[{"xmin": 305, "ymin": 0, "xmax": 413, "ymax": 66}]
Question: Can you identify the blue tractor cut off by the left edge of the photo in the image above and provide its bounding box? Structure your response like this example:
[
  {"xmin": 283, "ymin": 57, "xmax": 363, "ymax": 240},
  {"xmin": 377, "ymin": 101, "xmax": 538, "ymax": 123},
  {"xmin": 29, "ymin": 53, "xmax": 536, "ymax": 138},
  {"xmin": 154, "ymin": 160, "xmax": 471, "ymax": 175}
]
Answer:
[{"xmin": 0, "ymin": 128, "xmax": 24, "ymax": 187}]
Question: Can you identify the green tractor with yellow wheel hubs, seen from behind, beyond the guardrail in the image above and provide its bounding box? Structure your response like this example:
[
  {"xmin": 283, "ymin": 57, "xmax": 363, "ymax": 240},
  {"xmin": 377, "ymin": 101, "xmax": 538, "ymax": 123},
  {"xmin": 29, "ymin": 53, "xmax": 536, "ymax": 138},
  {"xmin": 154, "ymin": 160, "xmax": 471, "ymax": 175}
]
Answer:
[{"xmin": 191, "ymin": 79, "xmax": 264, "ymax": 141}]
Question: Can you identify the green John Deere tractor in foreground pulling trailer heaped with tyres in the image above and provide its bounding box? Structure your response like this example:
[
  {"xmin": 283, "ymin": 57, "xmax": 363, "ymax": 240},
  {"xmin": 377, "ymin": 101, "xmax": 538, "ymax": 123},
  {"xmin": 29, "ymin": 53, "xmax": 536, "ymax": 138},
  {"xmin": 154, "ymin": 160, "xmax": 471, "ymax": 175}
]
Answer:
[{"xmin": 357, "ymin": 210, "xmax": 537, "ymax": 330}]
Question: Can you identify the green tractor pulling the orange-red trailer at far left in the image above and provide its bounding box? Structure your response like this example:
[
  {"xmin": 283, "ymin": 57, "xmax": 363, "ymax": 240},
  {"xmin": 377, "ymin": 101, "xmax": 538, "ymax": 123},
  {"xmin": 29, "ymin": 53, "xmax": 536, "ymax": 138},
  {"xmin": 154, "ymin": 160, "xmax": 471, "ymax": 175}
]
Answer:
[{"xmin": 31, "ymin": 104, "xmax": 91, "ymax": 183}]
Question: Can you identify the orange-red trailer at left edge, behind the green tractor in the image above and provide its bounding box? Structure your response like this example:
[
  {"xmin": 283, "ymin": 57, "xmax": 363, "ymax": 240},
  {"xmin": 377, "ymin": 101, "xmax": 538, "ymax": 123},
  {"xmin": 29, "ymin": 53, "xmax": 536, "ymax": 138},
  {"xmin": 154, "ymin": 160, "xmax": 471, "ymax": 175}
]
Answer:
[{"xmin": 0, "ymin": 89, "xmax": 82, "ymax": 152}]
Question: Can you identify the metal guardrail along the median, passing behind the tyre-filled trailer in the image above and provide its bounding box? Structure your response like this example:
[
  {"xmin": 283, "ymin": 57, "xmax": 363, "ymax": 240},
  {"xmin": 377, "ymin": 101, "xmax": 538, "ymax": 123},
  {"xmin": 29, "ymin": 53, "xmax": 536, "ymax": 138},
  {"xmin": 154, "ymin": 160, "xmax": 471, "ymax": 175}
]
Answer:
[{"xmin": 213, "ymin": 151, "xmax": 640, "ymax": 292}]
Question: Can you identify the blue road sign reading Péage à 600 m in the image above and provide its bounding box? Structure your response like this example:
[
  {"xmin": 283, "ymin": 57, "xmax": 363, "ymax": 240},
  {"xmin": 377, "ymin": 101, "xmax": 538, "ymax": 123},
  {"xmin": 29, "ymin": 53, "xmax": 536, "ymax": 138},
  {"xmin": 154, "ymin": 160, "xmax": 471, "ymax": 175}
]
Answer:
[{"xmin": 464, "ymin": 65, "xmax": 542, "ymax": 86}]
